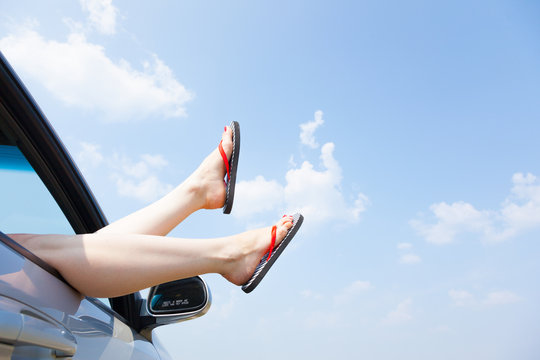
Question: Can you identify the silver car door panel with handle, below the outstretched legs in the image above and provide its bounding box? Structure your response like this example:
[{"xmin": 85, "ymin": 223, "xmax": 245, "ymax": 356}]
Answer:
[{"xmin": 0, "ymin": 234, "xmax": 159, "ymax": 360}]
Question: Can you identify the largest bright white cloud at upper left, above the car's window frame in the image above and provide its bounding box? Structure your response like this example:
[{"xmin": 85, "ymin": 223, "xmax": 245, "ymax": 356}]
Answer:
[{"xmin": 0, "ymin": 23, "xmax": 193, "ymax": 122}]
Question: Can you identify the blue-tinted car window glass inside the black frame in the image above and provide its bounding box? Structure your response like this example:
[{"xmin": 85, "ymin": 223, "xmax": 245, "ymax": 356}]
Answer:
[{"xmin": 0, "ymin": 145, "xmax": 74, "ymax": 234}]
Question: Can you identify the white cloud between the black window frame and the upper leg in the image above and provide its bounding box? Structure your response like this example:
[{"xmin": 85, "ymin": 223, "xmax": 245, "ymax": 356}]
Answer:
[{"xmin": 77, "ymin": 143, "xmax": 174, "ymax": 202}]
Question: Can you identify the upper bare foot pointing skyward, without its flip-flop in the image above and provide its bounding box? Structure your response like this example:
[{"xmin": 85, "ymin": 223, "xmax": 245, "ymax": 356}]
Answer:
[{"xmin": 187, "ymin": 126, "xmax": 233, "ymax": 209}]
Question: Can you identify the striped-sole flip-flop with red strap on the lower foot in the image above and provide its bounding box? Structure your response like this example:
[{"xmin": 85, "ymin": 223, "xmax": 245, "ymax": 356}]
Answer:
[{"xmin": 242, "ymin": 214, "xmax": 304, "ymax": 293}]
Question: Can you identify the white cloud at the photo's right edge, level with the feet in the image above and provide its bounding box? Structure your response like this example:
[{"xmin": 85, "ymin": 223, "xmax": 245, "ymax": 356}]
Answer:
[{"xmin": 410, "ymin": 173, "xmax": 540, "ymax": 244}]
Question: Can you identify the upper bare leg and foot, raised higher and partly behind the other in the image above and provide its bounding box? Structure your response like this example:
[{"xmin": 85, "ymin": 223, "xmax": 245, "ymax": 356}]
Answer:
[{"xmin": 98, "ymin": 127, "xmax": 232, "ymax": 236}]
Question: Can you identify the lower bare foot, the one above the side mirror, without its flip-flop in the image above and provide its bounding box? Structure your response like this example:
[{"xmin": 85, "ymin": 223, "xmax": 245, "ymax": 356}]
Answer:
[{"xmin": 221, "ymin": 215, "xmax": 293, "ymax": 285}]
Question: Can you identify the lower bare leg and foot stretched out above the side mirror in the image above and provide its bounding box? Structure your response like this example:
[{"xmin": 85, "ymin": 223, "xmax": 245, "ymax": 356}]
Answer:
[{"xmin": 11, "ymin": 217, "xmax": 292, "ymax": 297}]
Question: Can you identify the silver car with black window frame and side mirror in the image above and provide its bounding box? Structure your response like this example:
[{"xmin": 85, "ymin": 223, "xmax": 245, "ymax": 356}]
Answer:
[{"xmin": 0, "ymin": 52, "xmax": 211, "ymax": 359}]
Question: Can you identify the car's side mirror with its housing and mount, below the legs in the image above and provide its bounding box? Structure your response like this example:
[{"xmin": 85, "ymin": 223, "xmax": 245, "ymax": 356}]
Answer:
[{"xmin": 139, "ymin": 276, "xmax": 212, "ymax": 340}]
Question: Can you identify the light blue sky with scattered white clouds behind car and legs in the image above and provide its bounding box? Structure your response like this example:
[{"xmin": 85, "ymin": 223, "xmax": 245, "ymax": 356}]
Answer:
[{"xmin": 0, "ymin": 0, "xmax": 540, "ymax": 359}]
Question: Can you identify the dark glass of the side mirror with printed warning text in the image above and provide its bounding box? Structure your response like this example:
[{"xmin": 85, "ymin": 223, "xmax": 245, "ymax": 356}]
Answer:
[{"xmin": 148, "ymin": 276, "xmax": 208, "ymax": 315}]
